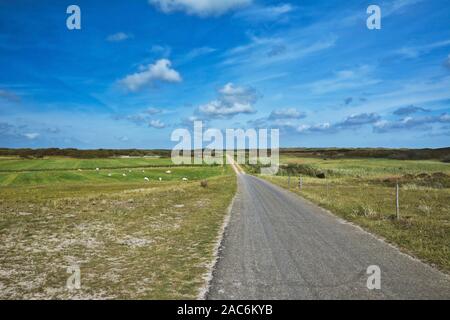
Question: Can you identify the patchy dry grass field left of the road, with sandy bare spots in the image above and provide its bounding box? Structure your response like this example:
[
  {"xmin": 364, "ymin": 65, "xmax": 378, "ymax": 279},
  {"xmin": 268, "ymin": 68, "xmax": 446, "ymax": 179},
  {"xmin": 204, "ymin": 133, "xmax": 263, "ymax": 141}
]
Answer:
[{"xmin": 0, "ymin": 159, "xmax": 236, "ymax": 299}]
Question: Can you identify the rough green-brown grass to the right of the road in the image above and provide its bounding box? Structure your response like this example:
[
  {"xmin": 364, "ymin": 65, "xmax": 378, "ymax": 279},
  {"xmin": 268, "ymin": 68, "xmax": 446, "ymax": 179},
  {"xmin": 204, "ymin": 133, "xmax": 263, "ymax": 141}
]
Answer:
[{"xmin": 261, "ymin": 159, "xmax": 450, "ymax": 273}]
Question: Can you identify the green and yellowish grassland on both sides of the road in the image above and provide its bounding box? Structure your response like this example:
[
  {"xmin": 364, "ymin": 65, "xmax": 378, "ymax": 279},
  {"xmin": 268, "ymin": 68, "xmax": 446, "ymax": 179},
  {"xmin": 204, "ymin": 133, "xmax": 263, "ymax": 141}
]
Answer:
[{"xmin": 0, "ymin": 153, "xmax": 450, "ymax": 299}]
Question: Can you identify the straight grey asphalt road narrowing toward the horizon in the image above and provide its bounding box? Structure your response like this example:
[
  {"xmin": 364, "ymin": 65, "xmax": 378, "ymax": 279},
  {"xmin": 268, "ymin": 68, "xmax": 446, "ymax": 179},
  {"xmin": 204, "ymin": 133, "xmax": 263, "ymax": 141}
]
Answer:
[{"xmin": 207, "ymin": 166, "xmax": 450, "ymax": 299}]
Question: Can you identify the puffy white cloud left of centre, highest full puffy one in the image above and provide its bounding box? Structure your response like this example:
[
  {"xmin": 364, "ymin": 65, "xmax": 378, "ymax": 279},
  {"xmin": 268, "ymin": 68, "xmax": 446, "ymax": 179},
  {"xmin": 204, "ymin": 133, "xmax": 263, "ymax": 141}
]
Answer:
[{"xmin": 121, "ymin": 59, "xmax": 182, "ymax": 91}]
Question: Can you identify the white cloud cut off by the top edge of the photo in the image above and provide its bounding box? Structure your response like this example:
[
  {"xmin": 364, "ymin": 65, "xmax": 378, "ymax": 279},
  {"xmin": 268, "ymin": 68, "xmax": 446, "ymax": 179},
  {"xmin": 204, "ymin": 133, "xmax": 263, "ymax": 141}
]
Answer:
[{"xmin": 149, "ymin": 0, "xmax": 252, "ymax": 17}]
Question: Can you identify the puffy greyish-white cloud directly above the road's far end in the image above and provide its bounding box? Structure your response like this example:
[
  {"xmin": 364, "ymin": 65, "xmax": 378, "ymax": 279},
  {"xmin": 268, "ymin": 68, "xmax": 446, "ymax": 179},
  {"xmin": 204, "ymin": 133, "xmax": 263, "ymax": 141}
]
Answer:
[{"xmin": 198, "ymin": 83, "xmax": 259, "ymax": 118}]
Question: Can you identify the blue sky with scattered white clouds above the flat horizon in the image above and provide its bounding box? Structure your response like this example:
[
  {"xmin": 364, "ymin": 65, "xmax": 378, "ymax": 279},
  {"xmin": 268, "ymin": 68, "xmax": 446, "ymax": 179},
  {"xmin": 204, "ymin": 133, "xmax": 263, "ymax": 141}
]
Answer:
[{"xmin": 0, "ymin": 0, "xmax": 450, "ymax": 148}]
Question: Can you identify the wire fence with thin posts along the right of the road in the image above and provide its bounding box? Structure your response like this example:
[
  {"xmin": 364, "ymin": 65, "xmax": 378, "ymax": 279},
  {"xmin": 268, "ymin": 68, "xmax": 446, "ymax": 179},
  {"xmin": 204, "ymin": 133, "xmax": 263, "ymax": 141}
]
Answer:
[{"xmin": 281, "ymin": 176, "xmax": 450, "ymax": 220}]
